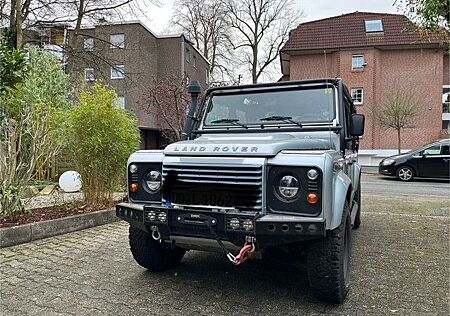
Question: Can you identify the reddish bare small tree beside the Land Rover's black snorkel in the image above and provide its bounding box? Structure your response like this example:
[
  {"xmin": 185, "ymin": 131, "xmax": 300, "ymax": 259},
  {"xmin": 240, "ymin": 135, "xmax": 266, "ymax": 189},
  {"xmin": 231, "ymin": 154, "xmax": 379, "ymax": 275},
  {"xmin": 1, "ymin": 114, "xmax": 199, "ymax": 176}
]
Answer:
[{"xmin": 143, "ymin": 74, "xmax": 189, "ymax": 141}]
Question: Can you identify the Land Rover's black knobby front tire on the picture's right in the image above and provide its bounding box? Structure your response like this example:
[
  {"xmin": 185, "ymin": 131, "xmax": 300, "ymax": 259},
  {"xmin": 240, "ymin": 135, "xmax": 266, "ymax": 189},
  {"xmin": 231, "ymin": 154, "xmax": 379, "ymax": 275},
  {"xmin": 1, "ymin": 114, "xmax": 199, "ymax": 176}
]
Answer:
[{"xmin": 307, "ymin": 202, "xmax": 352, "ymax": 303}]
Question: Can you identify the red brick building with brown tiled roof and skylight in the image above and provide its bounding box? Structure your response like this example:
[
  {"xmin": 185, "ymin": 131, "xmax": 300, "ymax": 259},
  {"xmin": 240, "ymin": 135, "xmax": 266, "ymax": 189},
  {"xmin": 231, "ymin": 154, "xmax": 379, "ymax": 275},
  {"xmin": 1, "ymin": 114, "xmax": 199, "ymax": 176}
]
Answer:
[{"xmin": 280, "ymin": 12, "xmax": 450, "ymax": 149}]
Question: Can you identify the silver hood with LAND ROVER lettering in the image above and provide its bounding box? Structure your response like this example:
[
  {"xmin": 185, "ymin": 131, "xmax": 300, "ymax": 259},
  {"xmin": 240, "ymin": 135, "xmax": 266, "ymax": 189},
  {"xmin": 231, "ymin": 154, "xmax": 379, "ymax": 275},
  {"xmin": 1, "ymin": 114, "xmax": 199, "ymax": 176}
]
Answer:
[{"xmin": 164, "ymin": 133, "xmax": 334, "ymax": 157}]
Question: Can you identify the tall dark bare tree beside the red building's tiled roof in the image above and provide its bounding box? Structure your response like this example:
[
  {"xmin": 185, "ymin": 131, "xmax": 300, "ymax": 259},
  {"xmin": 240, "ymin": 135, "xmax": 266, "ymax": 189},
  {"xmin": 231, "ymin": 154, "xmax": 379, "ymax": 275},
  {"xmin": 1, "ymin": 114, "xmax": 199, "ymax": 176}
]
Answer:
[{"xmin": 226, "ymin": 0, "xmax": 301, "ymax": 83}]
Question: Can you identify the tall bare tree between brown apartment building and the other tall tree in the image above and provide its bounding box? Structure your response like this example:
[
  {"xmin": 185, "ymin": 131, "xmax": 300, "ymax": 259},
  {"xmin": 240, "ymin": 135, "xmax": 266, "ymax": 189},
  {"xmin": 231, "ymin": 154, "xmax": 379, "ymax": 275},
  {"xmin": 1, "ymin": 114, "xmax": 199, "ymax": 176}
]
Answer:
[{"xmin": 172, "ymin": 0, "xmax": 233, "ymax": 84}]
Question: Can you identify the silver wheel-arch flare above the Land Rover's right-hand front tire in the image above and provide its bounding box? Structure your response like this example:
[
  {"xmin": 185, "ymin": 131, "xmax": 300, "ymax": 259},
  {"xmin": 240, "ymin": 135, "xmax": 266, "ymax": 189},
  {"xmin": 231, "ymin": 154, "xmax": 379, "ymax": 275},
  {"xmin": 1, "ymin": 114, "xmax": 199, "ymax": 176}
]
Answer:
[{"xmin": 329, "ymin": 170, "xmax": 352, "ymax": 229}]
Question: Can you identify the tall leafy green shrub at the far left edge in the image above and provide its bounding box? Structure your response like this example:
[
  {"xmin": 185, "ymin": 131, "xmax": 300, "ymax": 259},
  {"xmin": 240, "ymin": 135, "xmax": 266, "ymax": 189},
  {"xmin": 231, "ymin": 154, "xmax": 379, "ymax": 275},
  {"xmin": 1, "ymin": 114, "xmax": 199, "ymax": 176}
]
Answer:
[{"xmin": 0, "ymin": 47, "xmax": 70, "ymax": 218}]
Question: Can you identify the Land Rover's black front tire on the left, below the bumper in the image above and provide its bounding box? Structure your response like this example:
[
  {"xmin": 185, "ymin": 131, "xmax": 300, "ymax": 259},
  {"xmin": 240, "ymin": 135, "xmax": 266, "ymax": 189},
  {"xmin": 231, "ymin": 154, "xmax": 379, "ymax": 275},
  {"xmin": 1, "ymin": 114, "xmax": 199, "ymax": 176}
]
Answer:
[{"xmin": 129, "ymin": 226, "xmax": 186, "ymax": 271}]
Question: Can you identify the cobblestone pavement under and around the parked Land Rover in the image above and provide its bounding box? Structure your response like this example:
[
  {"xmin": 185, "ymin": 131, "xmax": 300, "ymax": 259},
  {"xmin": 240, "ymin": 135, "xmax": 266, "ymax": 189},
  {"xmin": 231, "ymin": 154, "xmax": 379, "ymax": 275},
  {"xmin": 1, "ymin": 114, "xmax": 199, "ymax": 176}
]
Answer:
[{"xmin": 0, "ymin": 197, "xmax": 450, "ymax": 315}]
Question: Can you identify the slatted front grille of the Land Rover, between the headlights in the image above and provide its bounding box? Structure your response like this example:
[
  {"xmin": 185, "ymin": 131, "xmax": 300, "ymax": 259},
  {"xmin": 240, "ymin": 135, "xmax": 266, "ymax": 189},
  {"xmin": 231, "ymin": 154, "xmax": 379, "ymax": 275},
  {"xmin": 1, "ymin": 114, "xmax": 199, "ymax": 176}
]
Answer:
[{"xmin": 162, "ymin": 163, "xmax": 262, "ymax": 211}]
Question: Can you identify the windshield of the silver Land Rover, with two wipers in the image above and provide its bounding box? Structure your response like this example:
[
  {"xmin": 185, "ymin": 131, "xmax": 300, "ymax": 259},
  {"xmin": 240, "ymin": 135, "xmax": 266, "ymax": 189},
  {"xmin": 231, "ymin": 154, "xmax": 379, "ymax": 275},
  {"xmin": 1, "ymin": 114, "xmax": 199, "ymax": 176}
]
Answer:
[{"xmin": 204, "ymin": 87, "xmax": 335, "ymax": 127}]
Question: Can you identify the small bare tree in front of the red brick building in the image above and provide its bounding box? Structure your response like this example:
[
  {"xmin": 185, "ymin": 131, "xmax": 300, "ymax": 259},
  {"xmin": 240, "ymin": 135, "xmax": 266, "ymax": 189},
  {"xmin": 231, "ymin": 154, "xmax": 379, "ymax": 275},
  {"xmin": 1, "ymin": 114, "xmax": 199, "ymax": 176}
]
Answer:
[{"xmin": 373, "ymin": 89, "xmax": 420, "ymax": 154}]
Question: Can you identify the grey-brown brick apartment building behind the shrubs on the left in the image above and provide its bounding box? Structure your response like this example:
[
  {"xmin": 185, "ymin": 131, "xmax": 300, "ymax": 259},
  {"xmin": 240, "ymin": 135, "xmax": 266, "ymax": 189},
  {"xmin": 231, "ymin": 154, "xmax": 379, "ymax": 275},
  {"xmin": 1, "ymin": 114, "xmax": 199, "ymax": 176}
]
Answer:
[{"xmin": 66, "ymin": 21, "xmax": 209, "ymax": 149}]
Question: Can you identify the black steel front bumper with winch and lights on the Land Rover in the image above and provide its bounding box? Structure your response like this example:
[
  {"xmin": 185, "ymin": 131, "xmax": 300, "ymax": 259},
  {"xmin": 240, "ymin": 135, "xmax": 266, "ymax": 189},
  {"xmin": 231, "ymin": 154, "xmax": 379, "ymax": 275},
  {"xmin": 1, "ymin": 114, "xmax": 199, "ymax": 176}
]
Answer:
[{"xmin": 116, "ymin": 203, "xmax": 326, "ymax": 248}]
